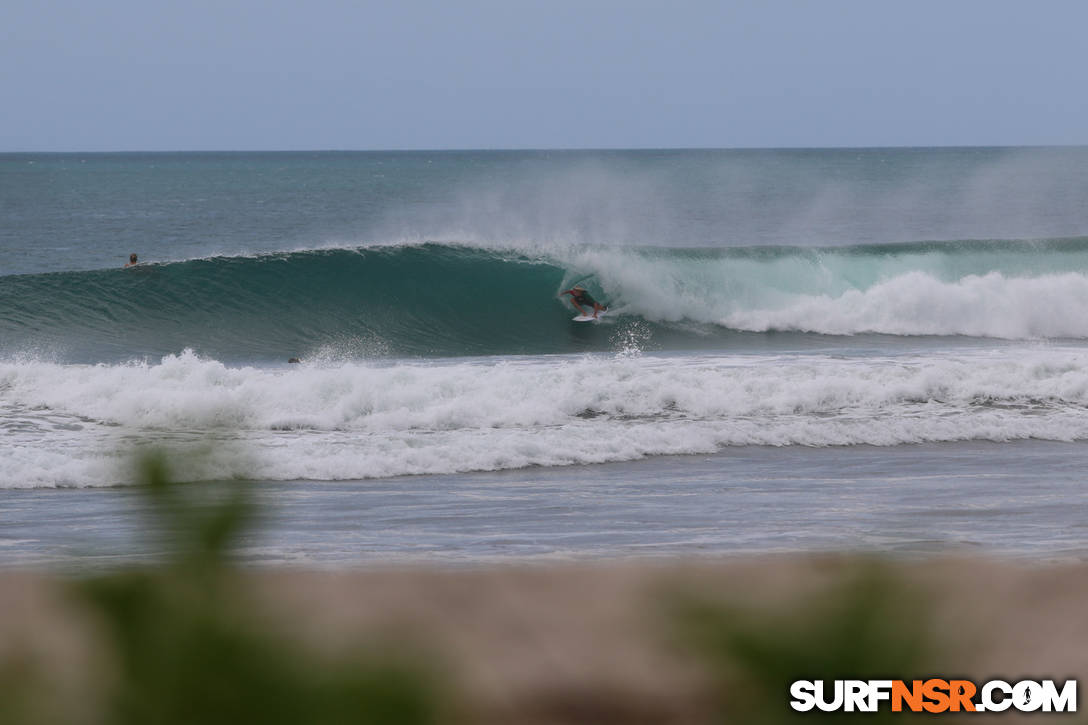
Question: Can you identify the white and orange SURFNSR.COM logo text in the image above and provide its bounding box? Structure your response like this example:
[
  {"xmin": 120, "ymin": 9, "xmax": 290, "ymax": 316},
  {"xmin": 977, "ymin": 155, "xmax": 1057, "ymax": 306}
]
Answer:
[{"xmin": 790, "ymin": 678, "xmax": 1077, "ymax": 713}]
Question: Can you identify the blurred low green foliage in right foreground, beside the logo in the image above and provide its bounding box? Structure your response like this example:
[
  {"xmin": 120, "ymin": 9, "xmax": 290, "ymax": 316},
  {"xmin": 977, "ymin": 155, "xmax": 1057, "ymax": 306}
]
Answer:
[{"xmin": 670, "ymin": 558, "xmax": 938, "ymax": 724}]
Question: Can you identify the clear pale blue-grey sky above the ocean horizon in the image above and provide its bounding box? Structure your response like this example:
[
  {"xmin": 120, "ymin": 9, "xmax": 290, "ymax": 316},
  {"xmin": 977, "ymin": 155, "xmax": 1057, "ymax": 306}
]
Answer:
[{"xmin": 0, "ymin": 0, "xmax": 1088, "ymax": 151}]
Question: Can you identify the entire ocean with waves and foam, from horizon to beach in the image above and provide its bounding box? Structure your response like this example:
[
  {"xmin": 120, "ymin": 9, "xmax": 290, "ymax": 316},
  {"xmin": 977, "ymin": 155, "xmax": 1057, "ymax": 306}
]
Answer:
[{"xmin": 0, "ymin": 147, "xmax": 1088, "ymax": 566}]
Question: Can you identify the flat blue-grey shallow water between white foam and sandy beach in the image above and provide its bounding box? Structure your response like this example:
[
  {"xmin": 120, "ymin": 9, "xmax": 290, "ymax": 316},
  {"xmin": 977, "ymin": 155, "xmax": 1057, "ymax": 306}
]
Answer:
[{"xmin": 6, "ymin": 441, "xmax": 1088, "ymax": 570}]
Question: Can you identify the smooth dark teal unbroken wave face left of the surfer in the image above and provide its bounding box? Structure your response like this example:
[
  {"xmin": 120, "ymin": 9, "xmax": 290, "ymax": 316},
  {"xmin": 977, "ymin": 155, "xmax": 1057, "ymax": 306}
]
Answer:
[{"xmin": 0, "ymin": 245, "xmax": 569, "ymax": 360}]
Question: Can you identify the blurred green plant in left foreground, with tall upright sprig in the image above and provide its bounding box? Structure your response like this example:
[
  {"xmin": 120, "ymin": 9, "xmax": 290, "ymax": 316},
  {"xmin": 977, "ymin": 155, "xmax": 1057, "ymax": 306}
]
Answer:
[{"xmin": 0, "ymin": 454, "xmax": 438, "ymax": 725}]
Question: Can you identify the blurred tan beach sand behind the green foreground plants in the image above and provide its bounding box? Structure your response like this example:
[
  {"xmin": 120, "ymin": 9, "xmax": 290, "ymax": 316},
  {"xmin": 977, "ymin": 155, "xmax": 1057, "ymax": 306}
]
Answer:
[{"xmin": 0, "ymin": 555, "xmax": 1088, "ymax": 723}]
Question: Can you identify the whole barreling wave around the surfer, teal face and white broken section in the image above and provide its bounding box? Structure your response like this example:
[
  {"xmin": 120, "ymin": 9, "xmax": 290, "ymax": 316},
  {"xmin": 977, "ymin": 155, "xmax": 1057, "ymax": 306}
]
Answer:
[{"xmin": 6, "ymin": 238, "xmax": 1088, "ymax": 361}]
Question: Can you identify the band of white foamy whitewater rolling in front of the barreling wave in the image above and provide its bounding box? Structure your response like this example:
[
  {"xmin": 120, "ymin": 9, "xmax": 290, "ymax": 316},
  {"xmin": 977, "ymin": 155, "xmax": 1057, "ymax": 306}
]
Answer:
[{"xmin": 6, "ymin": 345, "xmax": 1088, "ymax": 488}]
